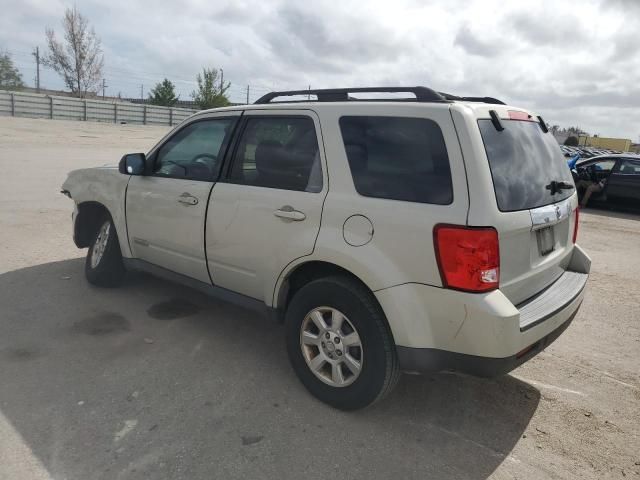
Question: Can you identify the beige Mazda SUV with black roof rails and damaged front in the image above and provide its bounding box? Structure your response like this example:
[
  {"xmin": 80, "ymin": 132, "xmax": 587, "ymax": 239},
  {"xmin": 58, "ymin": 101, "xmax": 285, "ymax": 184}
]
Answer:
[{"xmin": 63, "ymin": 87, "xmax": 590, "ymax": 410}]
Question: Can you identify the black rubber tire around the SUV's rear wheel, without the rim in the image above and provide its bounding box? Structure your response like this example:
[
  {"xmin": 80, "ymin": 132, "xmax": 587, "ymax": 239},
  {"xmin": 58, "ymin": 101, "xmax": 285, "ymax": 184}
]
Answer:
[{"xmin": 285, "ymin": 276, "xmax": 400, "ymax": 410}]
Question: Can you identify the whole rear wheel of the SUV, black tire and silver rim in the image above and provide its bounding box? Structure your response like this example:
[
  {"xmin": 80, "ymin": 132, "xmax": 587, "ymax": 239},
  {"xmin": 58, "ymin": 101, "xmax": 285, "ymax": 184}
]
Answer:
[{"xmin": 285, "ymin": 276, "xmax": 399, "ymax": 410}]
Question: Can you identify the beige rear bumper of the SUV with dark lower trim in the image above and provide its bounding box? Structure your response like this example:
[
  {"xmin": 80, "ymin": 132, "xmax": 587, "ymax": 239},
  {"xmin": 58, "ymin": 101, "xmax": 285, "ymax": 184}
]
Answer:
[{"xmin": 376, "ymin": 246, "xmax": 590, "ymax": 376}]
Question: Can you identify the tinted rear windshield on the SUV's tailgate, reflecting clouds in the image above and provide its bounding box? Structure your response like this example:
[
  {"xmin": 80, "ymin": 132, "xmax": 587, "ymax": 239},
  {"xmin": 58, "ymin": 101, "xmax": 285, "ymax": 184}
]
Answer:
[{"xmin": 478, "ymin": 119, "xmax": 575, "ymax": 212}]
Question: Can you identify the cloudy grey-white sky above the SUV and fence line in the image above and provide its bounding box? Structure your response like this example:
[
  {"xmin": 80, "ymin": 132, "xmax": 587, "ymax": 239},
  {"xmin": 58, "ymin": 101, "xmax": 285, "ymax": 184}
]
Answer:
[{"xmin": 0, "ymin": 0, "xmax": 640, "ymax": 141}]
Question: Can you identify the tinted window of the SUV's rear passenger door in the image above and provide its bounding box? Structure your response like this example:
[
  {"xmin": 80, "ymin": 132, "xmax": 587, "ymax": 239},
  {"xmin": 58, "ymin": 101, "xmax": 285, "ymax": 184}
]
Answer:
[{"xmin": 229, "ymin": 117, "xmax": 322, "ymax": 192}]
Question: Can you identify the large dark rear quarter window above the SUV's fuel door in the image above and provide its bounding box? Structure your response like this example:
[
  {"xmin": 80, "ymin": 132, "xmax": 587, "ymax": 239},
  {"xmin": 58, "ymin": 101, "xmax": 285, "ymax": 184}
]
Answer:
[{"xmin": 340, "ymin": 117, "xmax": 453, "ymax": 205}]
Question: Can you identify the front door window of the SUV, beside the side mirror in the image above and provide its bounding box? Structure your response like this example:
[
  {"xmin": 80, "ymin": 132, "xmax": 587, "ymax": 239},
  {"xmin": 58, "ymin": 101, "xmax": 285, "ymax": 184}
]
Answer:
[{"xmin": 155, "ymin": 118, "xmax": 236, "ymax": 180}]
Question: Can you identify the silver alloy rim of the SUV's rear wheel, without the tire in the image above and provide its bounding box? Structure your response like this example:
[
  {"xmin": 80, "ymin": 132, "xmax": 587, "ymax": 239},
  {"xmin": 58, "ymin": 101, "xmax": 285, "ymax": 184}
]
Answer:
[{"xmin": 300, "ymin": 307, "xmax": 364, "ymax": 387}]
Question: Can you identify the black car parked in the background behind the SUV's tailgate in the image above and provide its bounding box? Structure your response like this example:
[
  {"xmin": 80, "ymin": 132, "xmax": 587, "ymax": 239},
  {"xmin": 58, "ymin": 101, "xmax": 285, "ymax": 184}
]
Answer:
[{"xmin": 573, "ymin": 153, "xmax": 640, "ymax": 207}]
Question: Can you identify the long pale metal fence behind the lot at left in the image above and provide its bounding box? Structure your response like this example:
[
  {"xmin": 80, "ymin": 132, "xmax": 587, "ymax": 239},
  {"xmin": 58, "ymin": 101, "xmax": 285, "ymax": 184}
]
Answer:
[{"xmin": 0, "ymin": 90, "xmax": 197, "ymax": 125}]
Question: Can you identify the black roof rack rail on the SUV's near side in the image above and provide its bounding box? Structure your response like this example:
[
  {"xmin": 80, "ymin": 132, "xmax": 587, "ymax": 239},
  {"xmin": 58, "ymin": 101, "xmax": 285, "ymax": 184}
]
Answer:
[{"xmin": 254, "ymin": 87, "xmax": 450, "ymax": 104}]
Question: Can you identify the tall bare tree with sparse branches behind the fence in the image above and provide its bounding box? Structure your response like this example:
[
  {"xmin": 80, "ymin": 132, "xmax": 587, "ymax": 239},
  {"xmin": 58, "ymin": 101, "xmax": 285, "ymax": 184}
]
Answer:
[{"xmin": 43, "ymin": 6, "xmax": 104, "ymax": 98}]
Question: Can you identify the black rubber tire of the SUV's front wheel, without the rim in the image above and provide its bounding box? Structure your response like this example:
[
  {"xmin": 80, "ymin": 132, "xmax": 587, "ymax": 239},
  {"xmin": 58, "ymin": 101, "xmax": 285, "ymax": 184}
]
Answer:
[{"xmin": 84, "ymin": 214, "xmax": 125, "ymax": 287}]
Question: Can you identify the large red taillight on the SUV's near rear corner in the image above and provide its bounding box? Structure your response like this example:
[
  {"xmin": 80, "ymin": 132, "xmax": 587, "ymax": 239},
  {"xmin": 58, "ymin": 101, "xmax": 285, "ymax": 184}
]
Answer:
[{"xmin": 433, "ymin": 225, "xmax": 500, "ymax": 292}]
